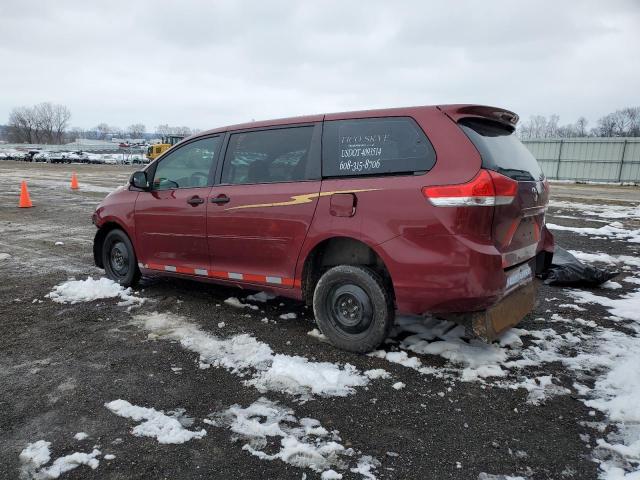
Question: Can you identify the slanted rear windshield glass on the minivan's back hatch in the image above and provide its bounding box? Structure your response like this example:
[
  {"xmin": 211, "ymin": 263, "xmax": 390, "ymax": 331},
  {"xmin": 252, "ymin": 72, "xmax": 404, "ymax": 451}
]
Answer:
[{"xmin": 459, "ymin": 119, "xmax": 544, "ymax": 181}]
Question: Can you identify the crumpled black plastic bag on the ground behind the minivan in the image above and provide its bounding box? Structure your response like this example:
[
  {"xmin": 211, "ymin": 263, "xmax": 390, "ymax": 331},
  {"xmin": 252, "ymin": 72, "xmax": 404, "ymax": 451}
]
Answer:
[{"xmin": 542, "ymin": 245, "xmax": 619, "ymax": 287}]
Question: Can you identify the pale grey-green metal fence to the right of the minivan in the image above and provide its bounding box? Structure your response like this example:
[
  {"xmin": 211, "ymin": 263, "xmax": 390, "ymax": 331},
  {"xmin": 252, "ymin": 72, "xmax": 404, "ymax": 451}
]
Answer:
[{"xmin": 523, "ymin": 138, "xmax": 640, "ymax": 183}]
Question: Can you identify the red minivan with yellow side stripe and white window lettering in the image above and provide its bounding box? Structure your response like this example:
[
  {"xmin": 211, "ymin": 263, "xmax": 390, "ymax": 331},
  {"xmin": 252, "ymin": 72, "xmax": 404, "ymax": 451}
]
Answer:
[{"xmin": 93, "ymin": 105, "xmax": 553, "ymax": 352}]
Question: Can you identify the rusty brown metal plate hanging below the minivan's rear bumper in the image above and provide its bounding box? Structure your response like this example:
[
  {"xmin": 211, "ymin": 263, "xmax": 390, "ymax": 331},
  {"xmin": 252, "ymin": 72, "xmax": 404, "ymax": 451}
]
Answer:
[{"xmin": 448, "ymin": 279, "xmax": 539, "ymax": 342}]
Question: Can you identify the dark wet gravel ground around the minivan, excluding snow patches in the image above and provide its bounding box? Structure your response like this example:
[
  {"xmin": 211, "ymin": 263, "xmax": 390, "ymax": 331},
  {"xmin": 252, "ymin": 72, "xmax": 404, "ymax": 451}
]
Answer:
[{"xmin": 0, "ymin": 161, "xmax": 640, "ymax": 480}]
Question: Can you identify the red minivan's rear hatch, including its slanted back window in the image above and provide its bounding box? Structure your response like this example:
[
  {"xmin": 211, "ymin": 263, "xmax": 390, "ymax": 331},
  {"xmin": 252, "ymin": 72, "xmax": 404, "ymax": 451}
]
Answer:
[{"xmin": 458, "ymin": 116, "xmax": 549, "ymax": 268}]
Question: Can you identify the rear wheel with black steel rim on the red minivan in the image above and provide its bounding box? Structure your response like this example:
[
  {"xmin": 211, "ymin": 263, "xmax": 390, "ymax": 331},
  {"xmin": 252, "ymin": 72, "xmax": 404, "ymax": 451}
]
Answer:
[{"xmin": 313, "ymin": 265, "xmax": 395, "ymax": 353}]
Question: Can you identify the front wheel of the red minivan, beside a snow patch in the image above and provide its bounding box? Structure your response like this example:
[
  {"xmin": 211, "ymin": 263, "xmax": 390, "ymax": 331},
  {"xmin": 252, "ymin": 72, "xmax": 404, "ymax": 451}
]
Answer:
[{"xmin": 102, "ymin": 229, "xmax": 140, "ymax": 287}]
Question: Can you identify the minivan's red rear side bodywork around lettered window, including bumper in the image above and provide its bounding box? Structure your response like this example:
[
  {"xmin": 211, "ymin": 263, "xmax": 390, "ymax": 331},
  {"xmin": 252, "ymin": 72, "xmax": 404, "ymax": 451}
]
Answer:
[{"xmin": 297, "ymin": 107, "xmax": 503, "ymax": 313}]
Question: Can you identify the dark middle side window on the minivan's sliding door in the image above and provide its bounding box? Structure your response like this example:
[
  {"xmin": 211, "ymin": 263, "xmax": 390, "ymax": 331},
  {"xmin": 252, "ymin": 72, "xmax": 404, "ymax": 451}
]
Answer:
[{"xmin": 222, "ymin": 126, "xmax": 314, "ymax": 184}]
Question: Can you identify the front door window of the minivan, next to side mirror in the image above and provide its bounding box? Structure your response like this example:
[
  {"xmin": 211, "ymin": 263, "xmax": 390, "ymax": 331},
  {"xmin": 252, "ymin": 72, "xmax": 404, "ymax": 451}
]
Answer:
[{"xmin": 152, "ymin": 137, "xmax": 220, "ymax": 190}]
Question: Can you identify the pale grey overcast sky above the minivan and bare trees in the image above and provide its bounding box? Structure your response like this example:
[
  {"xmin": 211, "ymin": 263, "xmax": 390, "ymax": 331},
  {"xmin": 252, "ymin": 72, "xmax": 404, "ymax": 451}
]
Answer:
[{"xmin": 0, "ymin": 0, "xmax": 640, "ymax": 131}]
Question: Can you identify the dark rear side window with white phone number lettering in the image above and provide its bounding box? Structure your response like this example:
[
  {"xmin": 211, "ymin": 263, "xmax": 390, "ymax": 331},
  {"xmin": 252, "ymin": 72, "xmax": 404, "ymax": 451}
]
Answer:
[{"xmin": 322, "ymin": 117, "xmax": 436, "ymax": 177}]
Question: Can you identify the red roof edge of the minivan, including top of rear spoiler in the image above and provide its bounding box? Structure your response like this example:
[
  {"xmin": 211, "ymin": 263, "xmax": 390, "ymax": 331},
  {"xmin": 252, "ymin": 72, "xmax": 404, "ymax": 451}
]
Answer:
[{"xmin": 197, "ymin": 104, "xmax": 517, "ymax": 136}]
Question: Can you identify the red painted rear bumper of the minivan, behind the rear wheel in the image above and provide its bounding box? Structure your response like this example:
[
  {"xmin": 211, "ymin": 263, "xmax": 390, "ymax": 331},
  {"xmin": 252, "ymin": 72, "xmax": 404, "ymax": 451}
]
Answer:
[{"xmin": 375, "ymin": 223, "xmax": 553, "ymax": 315}]
